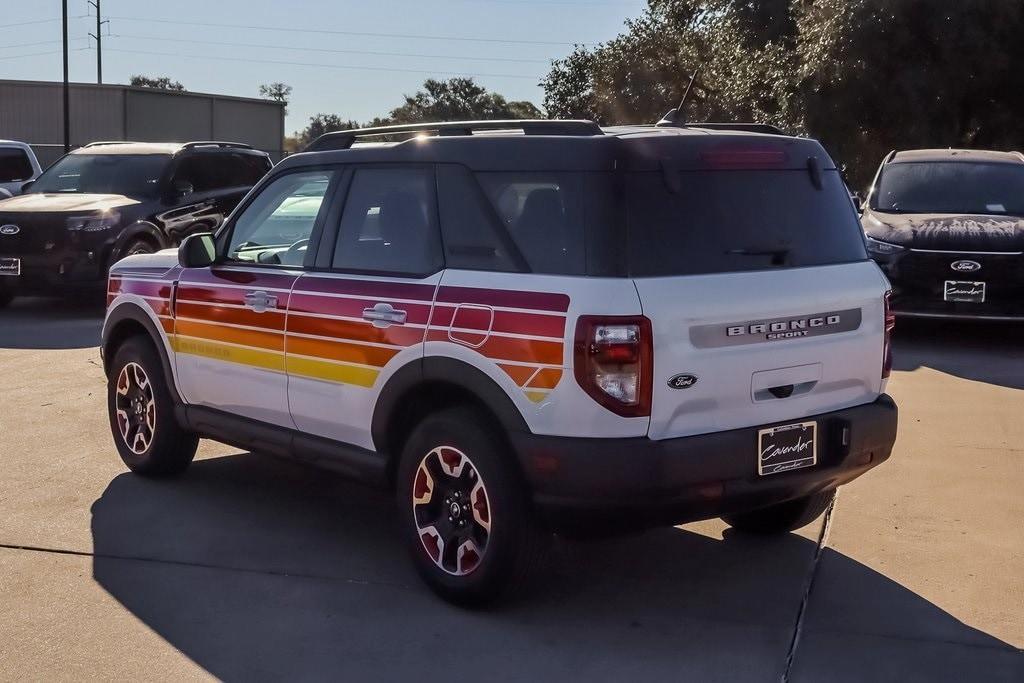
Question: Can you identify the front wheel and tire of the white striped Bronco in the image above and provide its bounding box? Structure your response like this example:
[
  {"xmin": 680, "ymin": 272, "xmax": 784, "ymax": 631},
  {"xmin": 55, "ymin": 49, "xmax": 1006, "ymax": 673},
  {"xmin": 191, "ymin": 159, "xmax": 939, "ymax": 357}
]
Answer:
[{"xmin": 106, "ymin": 336, "xmax": 199, "ymax": 477}]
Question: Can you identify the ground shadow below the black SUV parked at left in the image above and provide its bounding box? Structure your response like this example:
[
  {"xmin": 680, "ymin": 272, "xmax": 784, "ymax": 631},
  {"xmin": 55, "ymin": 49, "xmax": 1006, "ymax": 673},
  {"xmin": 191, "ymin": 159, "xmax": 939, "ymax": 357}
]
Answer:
[{"xmin": 0, "ymin": 294, "xmax": 103, "ymax": 349}]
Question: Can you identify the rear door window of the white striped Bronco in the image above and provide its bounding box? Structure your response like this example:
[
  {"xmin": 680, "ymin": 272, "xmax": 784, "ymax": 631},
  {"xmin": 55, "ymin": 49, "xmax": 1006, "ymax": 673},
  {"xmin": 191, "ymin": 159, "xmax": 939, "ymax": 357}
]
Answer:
[{"xmin": 332, "ymin": 168, "xmax": 441, "ymax": 274}]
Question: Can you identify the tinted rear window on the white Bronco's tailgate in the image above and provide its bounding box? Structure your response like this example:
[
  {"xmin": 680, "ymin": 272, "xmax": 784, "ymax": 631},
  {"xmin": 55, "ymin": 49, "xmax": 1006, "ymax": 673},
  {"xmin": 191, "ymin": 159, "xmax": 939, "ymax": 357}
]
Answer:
[{"xmin": 625, "ymin": 169, "xmax": 867, "ymax": 278}]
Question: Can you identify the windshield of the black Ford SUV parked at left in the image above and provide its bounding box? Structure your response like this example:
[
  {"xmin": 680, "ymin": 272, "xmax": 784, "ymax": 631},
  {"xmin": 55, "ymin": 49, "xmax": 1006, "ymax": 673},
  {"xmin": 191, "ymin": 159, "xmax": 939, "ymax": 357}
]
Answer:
[{"xmin": 31, "ymin": 154, "xmax": 171, "ymax": 199}]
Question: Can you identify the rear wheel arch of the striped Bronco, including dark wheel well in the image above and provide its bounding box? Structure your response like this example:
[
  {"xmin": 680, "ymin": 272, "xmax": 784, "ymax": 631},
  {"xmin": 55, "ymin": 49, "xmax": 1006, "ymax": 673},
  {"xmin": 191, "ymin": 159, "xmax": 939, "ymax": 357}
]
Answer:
[{"xmin": 371, "ymin": 356, "xmax": 529, "ymax": 480}]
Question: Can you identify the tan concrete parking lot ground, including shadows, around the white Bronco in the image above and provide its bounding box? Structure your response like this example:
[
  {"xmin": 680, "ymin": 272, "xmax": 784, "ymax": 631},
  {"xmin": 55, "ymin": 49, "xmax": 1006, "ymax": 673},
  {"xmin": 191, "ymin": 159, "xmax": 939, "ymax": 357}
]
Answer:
[{"xmin": 0, "ymin": 299, "xmax": 1024, "ymax": 681}]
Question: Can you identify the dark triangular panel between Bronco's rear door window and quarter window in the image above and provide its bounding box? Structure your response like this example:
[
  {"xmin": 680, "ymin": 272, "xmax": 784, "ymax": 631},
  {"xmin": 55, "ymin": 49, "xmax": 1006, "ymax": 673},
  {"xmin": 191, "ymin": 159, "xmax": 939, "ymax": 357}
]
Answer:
[{"xmin": 437, "ymin": 164, "xmax": 526, "ymax": 272}]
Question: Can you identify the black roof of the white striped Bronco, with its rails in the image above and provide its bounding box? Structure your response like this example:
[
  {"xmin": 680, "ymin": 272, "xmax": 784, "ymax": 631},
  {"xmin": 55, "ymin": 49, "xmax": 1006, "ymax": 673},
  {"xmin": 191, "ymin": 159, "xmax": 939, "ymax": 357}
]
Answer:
[{"xmin": 276, "ymin": 121, "xmax": 835, "ymax": 171}]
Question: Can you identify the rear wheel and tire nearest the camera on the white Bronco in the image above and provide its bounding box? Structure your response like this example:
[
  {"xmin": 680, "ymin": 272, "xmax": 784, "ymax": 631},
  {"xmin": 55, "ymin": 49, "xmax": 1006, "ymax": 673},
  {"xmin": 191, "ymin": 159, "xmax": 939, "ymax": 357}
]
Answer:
[{"xmin": 395, "ymin": 408, "xmax": 550, "ymax": 606}]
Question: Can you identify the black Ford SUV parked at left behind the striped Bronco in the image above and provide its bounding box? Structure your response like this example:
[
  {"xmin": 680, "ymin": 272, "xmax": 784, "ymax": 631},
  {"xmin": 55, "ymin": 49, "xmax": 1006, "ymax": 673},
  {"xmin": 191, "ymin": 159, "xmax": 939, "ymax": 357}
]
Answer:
[{"xmin": 0, "ymin": 142, "xmax": 272, "ymax": 305}]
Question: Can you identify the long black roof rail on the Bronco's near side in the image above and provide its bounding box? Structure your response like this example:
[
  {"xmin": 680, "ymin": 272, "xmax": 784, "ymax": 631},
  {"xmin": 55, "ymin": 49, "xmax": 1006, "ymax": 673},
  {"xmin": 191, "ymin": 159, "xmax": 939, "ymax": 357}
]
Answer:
[{"xmin": 304, "ymin": 119, "xmax": 604, "ymax": 152}]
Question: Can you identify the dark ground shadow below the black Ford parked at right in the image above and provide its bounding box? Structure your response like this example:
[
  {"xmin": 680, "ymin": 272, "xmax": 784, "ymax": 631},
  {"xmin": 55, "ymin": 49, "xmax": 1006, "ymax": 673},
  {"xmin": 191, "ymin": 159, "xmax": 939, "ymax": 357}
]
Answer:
[{"xmin": 893, "ymin": 318, "xmax": 1024, "ymax": 389}]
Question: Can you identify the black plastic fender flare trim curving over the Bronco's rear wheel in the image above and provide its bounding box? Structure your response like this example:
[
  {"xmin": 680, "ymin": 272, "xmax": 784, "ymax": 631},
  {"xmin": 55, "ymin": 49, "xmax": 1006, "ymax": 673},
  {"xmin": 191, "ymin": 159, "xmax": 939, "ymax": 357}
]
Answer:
[{"xmin": 370, "ymin": 356, "xmax": 529, "ymax": 455}]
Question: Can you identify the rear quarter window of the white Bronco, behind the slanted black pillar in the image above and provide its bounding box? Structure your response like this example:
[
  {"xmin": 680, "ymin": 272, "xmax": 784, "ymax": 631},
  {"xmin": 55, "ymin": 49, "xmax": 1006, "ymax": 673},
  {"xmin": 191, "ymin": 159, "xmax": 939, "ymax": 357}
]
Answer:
[{"xmin": 476, "ymin": 172, "xmax": 587, "ymax": 275}]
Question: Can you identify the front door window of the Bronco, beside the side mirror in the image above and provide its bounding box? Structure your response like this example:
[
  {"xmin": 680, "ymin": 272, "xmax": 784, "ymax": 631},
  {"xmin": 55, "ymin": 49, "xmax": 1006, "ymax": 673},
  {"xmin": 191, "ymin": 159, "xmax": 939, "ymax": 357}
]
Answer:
[{"xmin": 226, "ymin": 171, "xmax": 334, "ymax": 266}]
